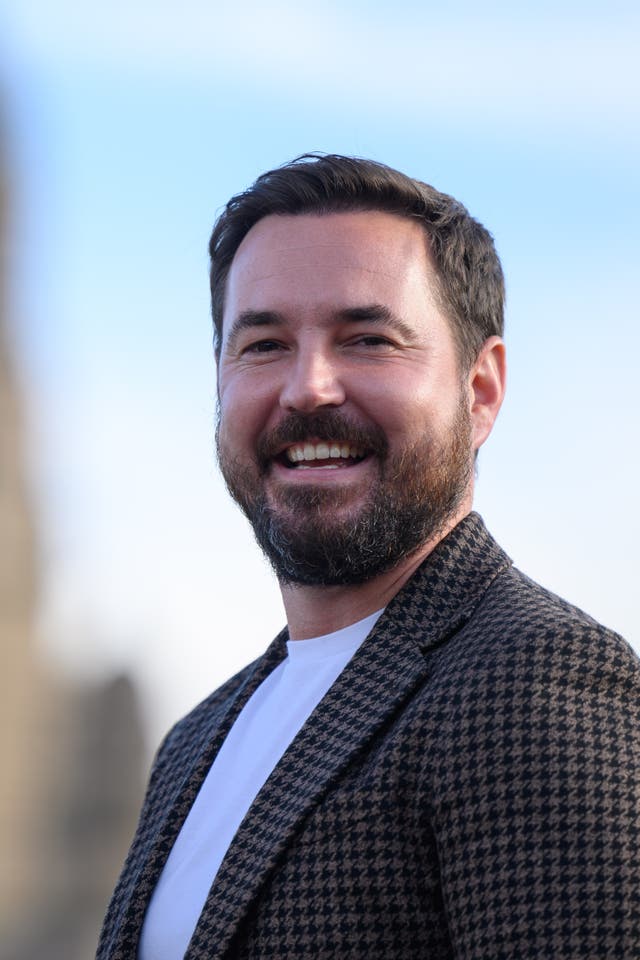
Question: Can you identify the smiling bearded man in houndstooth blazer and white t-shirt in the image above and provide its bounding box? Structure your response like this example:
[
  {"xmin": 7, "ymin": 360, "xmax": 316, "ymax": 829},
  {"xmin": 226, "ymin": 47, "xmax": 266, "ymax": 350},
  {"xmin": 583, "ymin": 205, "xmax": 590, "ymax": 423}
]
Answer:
[{"xmin": 98, "ymin": 156, "xmax": 640, "ymax": 960}]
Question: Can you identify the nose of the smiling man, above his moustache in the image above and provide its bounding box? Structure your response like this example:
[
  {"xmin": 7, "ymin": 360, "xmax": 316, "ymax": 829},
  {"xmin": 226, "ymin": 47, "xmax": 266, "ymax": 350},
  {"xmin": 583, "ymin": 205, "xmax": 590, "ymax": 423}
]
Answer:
[{"xmin": 280, "ymin": 348, "xmax": 345, "ymax": 413}]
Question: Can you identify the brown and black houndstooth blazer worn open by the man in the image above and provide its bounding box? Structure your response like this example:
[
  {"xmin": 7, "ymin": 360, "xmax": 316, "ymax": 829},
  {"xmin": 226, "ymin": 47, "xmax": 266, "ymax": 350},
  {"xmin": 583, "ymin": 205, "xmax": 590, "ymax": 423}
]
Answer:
[{"xmin": 98, "ymin": 514, "xmax": 640, "ymax": 960}]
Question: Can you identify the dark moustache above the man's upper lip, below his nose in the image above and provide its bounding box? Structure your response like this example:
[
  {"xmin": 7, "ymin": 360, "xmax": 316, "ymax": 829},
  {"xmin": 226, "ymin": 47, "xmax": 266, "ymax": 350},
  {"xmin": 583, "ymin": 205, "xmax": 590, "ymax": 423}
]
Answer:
[{"xmin": 256, "ymin": 410, "xmax": 389, "ymax": 470}]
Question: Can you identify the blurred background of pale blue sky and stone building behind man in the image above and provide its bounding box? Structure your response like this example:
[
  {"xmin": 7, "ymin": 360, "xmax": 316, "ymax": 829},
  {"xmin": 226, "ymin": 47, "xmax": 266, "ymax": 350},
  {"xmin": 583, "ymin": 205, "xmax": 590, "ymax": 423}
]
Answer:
[{"xmin": 0, "ymin": 0, "xmax": 640, "ymax": 960}]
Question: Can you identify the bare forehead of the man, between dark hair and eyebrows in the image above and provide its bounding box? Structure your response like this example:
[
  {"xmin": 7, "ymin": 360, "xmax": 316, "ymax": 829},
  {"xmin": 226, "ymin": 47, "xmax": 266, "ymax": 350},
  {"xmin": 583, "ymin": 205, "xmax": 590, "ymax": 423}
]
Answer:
[{"xmin": 225, "ymin": 211, "xmax": 436, "ymax": 318}]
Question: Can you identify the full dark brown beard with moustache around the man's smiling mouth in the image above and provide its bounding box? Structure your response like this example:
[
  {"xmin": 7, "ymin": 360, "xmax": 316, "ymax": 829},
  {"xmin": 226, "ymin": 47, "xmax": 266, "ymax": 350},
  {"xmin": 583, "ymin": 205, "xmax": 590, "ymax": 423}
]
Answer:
[{"xmin": 216, "ymin": 397, "xmax": 474, "ymax": 587}]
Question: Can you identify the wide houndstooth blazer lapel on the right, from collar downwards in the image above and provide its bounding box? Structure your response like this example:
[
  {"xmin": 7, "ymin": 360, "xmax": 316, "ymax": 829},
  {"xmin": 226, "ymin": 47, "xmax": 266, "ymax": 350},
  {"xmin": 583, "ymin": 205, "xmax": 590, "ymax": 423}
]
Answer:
[{"xmin": 185, "ymin": 514, "xmax": 510, "ymax": 960}]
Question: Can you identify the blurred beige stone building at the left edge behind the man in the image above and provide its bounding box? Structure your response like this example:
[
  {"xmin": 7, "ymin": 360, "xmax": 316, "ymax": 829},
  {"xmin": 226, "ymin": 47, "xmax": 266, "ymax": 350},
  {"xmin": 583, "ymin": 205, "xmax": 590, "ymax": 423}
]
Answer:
[{"xmin": 0, "ymin": 110, "xmax": 144, "ymax": 960}]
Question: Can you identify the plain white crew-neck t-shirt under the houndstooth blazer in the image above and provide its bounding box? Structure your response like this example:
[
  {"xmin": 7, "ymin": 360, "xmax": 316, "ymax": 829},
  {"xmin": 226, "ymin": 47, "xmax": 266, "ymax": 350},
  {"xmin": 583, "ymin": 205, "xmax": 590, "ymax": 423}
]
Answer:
[{"xmin": 138, "ymin": 610, "xmax": 382, "ymax": 960}]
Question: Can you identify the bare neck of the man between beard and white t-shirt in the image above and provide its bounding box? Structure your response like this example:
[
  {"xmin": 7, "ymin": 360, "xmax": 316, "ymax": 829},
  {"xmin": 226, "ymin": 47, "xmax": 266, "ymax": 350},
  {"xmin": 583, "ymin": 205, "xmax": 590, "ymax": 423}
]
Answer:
[{"xmin": 280, "ymin": 508, "xmax": 469, "ymax": 640}]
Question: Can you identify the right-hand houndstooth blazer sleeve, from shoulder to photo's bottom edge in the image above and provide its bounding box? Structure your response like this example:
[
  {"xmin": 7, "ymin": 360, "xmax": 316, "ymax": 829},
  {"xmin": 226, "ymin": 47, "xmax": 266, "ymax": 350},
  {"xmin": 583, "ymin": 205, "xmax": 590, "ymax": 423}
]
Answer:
[{"xmin": 410, "ymin": 552, "xmax": 640, "ymax": 957}]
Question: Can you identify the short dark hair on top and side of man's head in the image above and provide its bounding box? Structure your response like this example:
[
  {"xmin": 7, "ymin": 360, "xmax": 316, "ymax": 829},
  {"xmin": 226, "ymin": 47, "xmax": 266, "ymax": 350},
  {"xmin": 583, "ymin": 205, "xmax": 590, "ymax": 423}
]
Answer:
[{"xmin": 209, "ymin": 154, "xmax": 504, "ymax": 367}]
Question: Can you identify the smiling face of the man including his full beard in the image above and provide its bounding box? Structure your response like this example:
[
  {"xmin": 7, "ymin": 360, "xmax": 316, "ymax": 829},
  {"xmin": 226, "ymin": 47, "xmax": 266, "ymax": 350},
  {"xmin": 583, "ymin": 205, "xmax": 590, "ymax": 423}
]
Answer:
[{"xmin": 218, "ymin": 212, "xmax": 473, "ymax": 585}]
